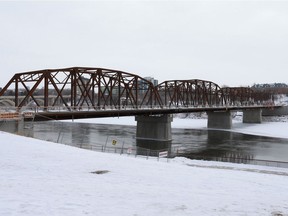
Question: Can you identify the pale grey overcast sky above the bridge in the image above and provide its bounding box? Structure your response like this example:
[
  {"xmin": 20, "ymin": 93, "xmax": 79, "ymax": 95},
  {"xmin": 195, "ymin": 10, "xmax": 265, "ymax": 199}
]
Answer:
[{"xmin": 0, "ymin": 0, "xmax": 288, "ymax": 87}]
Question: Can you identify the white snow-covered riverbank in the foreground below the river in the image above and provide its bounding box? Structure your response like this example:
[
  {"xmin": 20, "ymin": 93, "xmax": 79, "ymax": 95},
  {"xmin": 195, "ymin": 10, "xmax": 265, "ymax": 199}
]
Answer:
[{"xmin": 0, "ymin": 117, "xmax": 288, "ymax": 216}]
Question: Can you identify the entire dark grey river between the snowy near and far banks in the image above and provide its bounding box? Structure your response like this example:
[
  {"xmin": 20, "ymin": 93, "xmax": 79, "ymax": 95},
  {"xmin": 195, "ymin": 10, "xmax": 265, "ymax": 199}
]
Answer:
[{"xmin": 0, "ymin": 121, "xmax": 288, "ymax": 167}]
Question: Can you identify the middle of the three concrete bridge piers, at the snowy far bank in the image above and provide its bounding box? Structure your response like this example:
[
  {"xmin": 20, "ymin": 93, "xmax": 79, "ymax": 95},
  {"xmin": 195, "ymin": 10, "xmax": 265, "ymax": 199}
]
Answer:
[{"xmin": 207, "ymin": 111, "xmax": 232, "ymax": 129}]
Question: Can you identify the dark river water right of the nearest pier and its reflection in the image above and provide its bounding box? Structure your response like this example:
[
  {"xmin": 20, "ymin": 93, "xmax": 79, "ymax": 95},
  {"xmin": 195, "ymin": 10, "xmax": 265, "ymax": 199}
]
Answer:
[{"xmin": 172, "ymin": 126, "xmax": 288, "ymax": 163}]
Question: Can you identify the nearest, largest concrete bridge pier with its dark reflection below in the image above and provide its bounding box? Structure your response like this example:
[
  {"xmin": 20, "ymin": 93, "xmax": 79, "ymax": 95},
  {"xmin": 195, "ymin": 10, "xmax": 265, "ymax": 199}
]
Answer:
[{"xmin": 135, "ymin": 115, "xmax": 173, "ymax": 156}]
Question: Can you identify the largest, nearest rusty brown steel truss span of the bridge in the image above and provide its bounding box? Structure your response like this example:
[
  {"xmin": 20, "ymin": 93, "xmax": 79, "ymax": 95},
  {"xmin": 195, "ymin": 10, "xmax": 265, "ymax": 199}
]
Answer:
[{"xmin": 0, "ymin": 67, "xmax": 162, "ymax": 110}]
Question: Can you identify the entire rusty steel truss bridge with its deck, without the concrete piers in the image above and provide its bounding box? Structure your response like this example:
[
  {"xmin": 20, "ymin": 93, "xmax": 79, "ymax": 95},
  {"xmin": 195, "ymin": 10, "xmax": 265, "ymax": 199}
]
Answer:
[{"xmin": 0, "ymin": 67, "xmax": 273, "ymax": 120}]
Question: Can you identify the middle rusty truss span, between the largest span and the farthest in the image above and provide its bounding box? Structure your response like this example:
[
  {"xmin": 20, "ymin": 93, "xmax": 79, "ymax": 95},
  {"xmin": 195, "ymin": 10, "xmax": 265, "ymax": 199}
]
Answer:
[{"xmin": 157, "ymin": 79, "xmax": 226, "ymax": 107}]
